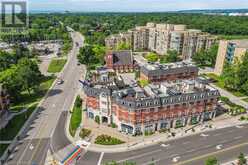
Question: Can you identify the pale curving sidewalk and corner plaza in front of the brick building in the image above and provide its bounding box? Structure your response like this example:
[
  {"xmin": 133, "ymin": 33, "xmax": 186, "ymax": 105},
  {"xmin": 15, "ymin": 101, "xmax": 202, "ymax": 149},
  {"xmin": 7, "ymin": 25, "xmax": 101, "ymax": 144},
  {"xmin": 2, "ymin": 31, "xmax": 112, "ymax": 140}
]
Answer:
[{"xmin": 66, "ymin": 112, "xmax": 248, "ymax": 153}]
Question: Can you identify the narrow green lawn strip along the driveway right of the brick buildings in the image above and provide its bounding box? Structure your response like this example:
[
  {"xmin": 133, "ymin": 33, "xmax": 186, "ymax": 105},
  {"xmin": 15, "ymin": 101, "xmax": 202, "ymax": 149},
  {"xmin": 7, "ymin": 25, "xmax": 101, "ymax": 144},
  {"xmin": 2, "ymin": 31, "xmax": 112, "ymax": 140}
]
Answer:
[{"xmin": 205, "ymin": 73, "xmax": 246, "ymax": 97}]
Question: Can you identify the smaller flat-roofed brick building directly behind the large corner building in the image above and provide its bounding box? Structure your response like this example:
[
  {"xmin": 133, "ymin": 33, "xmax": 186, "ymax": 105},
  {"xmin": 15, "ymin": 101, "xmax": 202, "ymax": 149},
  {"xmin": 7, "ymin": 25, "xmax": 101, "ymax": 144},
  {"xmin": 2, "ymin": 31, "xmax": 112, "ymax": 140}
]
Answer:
[{"xmin": 140, "ymin": 62, "xmax": 198, "ymax": 83}]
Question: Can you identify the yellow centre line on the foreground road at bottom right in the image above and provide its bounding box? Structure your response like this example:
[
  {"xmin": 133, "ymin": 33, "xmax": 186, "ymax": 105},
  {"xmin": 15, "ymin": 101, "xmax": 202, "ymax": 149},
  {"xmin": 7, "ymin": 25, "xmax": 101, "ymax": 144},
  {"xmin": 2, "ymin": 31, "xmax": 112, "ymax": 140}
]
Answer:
[{"xmin": 176, "ymin": 142, "xmax": 248, "ymax": 165}]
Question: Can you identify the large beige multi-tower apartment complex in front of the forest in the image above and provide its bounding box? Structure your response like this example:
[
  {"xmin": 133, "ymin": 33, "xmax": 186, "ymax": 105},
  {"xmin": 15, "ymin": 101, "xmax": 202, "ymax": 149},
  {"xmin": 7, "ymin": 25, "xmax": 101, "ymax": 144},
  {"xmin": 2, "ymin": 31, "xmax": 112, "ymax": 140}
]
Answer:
[{"xmin": 106, "ymin": 23, "xmax": 217, "ymax": 60}]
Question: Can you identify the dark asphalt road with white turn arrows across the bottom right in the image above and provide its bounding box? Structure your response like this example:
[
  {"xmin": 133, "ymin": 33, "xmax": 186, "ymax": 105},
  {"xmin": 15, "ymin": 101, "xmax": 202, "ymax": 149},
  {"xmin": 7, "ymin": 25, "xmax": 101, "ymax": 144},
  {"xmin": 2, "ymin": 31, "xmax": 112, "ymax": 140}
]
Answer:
[{"xmin": 78, "ymin": 125, "xmax": 248, "ymax": 165}]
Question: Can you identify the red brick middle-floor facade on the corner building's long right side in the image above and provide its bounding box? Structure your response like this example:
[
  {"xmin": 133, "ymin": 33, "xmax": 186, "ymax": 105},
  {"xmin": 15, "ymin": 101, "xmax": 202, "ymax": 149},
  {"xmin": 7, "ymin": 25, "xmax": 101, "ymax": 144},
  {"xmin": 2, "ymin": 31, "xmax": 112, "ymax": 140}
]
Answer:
[{"xmin": 112, "ymin": 99, "xmax": 217, "ymax": 125}]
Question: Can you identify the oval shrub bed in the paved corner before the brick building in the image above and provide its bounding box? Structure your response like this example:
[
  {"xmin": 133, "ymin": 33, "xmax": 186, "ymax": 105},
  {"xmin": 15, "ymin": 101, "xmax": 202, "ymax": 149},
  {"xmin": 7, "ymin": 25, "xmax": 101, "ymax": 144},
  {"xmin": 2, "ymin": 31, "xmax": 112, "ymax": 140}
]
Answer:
[{"xmin": 95, "ymin": 135, "xmax": 125, "ymax": 145}]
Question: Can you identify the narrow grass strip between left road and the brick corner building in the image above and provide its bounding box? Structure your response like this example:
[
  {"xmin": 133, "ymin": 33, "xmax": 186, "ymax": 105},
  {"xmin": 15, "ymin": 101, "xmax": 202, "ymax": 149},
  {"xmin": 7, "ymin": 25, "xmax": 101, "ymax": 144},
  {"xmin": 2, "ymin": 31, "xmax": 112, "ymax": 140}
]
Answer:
[{"xmin": 69, "ymin": 96, "xmax": 82, "ymax": 137}]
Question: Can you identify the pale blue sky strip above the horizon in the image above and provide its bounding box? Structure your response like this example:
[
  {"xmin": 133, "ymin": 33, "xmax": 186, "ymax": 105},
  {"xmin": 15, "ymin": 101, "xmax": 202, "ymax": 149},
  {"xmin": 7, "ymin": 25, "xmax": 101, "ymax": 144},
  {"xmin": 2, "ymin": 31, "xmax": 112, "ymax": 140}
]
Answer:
[{"xmin": 28, "ymin": 0, "xmax": 248, "ymax": 12}]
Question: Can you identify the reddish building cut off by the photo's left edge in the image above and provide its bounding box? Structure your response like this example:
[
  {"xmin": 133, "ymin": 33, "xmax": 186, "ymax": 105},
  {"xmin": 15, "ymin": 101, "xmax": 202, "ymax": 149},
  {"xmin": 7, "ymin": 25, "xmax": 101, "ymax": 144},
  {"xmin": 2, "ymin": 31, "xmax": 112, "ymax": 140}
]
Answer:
[{"xmin": 0, "ymin": 84, "xmax": 9, "ymax": 118}]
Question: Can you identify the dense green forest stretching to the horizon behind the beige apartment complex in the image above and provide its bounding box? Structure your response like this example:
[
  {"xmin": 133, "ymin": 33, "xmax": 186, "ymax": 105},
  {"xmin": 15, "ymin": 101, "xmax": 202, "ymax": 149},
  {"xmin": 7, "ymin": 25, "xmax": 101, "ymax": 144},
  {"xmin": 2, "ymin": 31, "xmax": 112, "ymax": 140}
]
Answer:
[{"xmin": 58, "ymin": 13, "xmax": 248, "ymax": 45}]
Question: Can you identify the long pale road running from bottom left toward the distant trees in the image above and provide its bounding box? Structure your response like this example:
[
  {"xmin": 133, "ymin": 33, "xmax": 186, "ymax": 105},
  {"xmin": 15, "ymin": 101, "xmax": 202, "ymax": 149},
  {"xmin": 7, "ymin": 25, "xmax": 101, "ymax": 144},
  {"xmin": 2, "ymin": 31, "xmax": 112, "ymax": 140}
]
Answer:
[{"xmin": 7, "ymin": 32, "xmax": 83, "ymax": 165}]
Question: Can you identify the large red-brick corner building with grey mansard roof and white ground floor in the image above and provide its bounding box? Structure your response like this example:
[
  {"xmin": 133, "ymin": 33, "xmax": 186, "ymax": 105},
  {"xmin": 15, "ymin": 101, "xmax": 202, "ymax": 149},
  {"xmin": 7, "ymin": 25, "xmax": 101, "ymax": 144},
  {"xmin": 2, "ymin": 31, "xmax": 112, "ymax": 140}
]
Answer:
[{"xmin": 83, "ymin": 71, "xmax": 220, "ymax": 135}]
